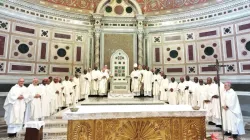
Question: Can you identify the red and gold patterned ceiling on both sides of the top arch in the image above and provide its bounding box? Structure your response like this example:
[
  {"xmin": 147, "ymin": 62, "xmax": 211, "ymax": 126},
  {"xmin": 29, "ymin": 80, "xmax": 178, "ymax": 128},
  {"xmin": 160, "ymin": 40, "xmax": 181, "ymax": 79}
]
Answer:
[{"xmin": 40, "ymin": 0, "xmax": 223, "ymax": 15}]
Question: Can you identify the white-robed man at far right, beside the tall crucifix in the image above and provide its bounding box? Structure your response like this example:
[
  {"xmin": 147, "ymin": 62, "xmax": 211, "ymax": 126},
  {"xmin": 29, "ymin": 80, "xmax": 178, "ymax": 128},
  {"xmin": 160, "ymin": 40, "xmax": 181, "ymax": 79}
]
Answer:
[{"xmin": 222, "ymin": 82, "xmax": 245, "ymax": 139}]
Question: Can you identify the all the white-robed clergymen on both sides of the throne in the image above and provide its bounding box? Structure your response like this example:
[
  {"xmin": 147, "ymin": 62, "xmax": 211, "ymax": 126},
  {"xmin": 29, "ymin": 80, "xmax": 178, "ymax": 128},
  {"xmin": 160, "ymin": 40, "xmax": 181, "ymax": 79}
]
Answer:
[{"xmin": 4, "ymin": 64, "xmax": 245, "ymax": 137}]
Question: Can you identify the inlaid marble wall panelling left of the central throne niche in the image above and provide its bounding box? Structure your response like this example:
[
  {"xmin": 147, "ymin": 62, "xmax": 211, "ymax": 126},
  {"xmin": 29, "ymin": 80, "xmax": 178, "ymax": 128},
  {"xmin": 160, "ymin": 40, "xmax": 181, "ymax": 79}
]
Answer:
[{"xmin": 0, "ymin": 18, "xmax": 89, "ymax": 76}]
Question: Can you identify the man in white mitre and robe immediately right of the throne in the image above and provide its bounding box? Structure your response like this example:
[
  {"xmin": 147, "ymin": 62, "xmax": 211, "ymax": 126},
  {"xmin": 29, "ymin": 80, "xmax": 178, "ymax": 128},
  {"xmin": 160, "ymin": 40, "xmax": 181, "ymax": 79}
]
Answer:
[{"xmin": 130, "ymin": 63, "xmax": 141, "ymax": 96}]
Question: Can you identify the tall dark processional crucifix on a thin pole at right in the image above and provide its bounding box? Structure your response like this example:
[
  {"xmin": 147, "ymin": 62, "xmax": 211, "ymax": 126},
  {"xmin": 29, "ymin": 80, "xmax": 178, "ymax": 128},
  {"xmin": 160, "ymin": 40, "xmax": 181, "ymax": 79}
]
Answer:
[{"xmin": 208, "ymin": 59, "xmax": 227, "ymax": 140}]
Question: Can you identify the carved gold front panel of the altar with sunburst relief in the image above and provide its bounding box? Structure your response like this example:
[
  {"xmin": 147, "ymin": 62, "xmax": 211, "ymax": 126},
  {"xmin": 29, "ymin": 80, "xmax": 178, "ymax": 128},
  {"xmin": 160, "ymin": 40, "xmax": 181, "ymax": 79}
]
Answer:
[{"xmin": 68, "ymin": 117, "xmax": 206, "ymax": 140}]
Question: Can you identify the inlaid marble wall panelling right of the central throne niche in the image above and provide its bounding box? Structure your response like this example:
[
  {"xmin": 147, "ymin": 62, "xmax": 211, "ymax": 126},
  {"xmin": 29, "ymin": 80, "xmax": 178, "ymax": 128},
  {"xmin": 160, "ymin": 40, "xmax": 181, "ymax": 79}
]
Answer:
[{"xmin": 149, "ymin": 18, "xmax": 250, "ymax": 78}]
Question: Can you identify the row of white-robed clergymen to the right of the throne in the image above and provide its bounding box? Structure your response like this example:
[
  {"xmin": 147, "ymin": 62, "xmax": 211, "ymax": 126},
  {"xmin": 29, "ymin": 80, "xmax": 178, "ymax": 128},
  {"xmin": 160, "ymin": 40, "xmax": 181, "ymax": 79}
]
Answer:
[{"xmin": 130, "ymin": 64, "xmax": 245, "ymax": 138}]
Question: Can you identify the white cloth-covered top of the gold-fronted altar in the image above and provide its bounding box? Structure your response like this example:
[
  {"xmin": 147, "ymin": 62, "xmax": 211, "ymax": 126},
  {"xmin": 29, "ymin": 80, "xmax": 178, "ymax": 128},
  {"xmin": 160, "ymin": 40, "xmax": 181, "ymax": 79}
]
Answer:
[{"xmin": 63, "ymin": 105, "xmax": 206, "ymax": 120}]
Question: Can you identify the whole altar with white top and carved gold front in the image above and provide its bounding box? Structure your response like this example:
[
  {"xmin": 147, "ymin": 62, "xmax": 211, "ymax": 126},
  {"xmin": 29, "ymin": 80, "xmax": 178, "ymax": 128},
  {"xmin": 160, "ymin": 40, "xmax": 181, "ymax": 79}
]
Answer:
[{"xmin": 63, "ymin": 105, "xmax": 206, "ymax": 140}]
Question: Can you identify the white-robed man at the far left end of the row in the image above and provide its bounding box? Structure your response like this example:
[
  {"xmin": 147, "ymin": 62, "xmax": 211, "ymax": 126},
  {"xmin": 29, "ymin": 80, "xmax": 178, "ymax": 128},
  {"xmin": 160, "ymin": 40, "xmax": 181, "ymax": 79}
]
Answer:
[{"xmin": 3, "ymin": 78, "xmax": 29, "ymax": 137}]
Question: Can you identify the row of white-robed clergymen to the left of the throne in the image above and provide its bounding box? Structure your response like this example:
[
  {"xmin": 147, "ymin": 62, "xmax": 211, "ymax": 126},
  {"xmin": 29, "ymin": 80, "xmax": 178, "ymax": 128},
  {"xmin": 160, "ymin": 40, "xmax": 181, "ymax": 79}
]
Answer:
[{"xmin": 4, "ymin": 65, "xmax": 109, "ymax": 137}]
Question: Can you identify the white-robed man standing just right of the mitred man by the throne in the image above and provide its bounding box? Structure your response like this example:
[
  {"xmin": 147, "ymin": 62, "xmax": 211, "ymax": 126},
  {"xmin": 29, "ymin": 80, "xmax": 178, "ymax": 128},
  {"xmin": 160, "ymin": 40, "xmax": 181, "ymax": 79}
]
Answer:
[{"xmin": 142, "ymin": 67, "xmax": 153, "ymax": 96}]
